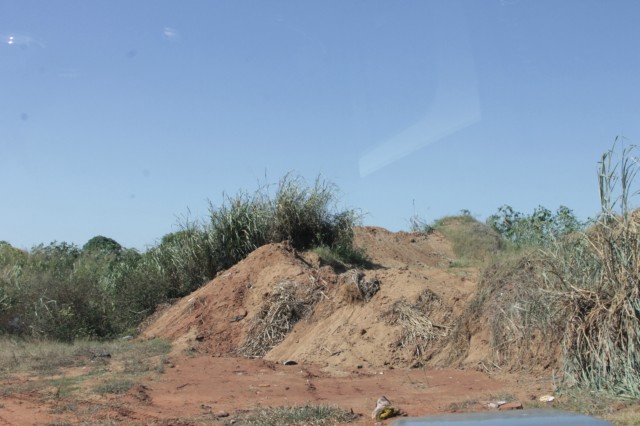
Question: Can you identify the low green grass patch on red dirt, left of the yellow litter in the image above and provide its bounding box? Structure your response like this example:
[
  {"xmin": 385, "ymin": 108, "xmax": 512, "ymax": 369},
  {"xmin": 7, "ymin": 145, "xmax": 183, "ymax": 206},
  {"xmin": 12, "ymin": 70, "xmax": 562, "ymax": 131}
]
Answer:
[{"xmin": 237, "ymin": 405, "xmax": 359, "ymax": 426}]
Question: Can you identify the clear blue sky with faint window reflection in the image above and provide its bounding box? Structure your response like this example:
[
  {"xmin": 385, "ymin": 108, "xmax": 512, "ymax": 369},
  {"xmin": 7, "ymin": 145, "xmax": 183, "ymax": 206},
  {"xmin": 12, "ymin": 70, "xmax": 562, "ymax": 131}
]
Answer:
[{"xmin": 0, "ymin": 0, "xmax": 640, "ymax": 249}]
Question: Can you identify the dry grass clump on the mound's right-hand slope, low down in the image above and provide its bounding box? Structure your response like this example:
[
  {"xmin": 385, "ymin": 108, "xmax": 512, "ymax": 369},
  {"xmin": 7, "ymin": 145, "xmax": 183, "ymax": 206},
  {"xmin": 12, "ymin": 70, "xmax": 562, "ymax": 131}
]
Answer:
[{"xmin": 385, "ymin": 290, "xmax": 451, "ymax": 358}]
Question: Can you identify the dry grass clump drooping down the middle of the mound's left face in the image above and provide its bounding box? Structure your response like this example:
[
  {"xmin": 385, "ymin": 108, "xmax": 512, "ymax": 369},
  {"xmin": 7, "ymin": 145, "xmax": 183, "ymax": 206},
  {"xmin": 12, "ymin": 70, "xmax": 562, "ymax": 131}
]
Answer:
[{"xmin": 238, "ymin": 281, "xmax": 321, "ymax": 357}]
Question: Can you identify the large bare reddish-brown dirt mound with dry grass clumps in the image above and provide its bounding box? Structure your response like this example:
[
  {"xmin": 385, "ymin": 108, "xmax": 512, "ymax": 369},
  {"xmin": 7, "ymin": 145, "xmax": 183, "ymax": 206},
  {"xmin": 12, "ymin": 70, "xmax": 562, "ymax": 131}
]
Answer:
[{"xmin": 142, "ymin": 227, "xmax": 484, "ymax": 374}]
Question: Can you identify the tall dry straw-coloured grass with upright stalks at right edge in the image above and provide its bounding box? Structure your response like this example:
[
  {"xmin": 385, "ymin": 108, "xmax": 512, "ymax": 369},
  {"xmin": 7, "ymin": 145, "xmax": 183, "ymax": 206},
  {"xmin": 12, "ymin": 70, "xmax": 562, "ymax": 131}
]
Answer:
[{"xmin": 546, "ymin": 145, "xmax": 640, "ymax": 398}]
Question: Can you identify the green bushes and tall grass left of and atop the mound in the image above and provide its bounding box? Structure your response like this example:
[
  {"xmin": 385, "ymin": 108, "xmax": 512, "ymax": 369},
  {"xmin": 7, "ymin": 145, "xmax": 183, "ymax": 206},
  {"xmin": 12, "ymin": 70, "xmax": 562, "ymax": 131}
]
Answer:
[{"xmin": 0, "ymin": 171, "xmax": 366, "ymax": 341}]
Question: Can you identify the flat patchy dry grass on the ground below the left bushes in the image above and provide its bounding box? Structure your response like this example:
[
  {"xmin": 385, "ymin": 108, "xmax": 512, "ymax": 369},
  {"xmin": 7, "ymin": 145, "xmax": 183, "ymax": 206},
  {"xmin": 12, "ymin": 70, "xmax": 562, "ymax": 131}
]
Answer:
[{"xmin": 0, "ymin": 337, "xmax": 170, "ymax": 404}]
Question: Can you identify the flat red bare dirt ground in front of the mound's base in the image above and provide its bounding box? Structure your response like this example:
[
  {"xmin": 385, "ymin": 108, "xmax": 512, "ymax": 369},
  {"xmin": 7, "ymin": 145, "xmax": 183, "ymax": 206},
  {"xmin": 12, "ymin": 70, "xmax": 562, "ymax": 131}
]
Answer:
[{"xmin": 0, "ymin": 356, "xmax": 549, "ymax": 426}]
